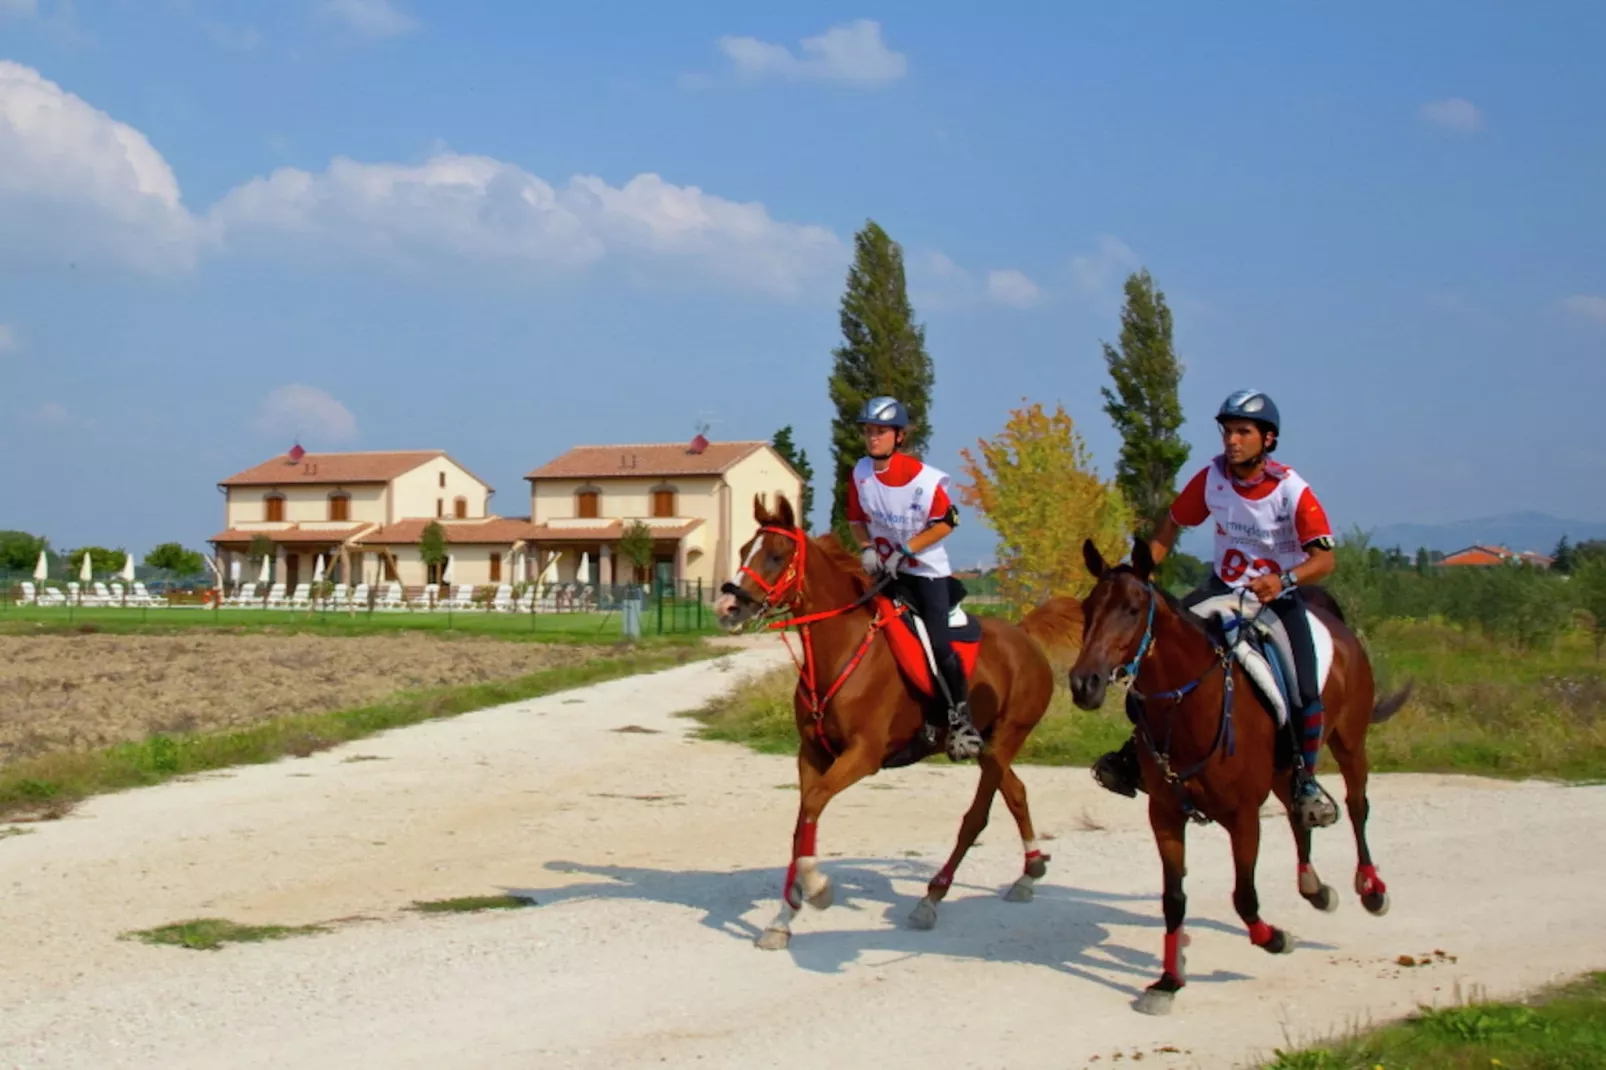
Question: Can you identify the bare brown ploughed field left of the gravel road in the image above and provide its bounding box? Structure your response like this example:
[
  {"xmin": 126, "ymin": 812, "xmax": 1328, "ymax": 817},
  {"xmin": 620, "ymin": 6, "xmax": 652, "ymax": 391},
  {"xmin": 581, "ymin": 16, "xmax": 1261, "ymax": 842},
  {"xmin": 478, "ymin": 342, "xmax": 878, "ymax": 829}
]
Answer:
[{"xmin": 0, "ymin": 633, "xmax": 607, "ymax": 765}]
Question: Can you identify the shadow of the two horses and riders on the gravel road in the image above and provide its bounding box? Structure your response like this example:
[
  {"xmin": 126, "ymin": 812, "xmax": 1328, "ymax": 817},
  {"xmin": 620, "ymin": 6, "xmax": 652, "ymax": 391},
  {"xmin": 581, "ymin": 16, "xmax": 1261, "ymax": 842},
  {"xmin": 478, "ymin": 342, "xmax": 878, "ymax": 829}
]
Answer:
[{"xmin": 504, "ymin": 858, "xmax": 1331, "ymax": 996}]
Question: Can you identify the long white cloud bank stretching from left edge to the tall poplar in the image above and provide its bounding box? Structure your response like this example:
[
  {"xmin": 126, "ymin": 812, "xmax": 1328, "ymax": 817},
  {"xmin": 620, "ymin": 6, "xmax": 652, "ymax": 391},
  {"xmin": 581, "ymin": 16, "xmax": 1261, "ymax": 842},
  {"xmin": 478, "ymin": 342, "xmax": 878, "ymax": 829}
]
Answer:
[{"xmin": 0, "ymin": 61, "xmax": 848, "ymax": 296}]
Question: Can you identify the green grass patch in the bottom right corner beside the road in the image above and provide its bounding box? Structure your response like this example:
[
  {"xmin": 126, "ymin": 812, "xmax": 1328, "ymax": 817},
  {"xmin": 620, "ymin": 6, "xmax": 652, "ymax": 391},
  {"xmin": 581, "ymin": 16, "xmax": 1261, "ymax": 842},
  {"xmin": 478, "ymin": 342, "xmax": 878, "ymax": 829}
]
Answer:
[{"xmin": 1266, "ymin": 974, "xmax": 1606, "ymax": 1070}]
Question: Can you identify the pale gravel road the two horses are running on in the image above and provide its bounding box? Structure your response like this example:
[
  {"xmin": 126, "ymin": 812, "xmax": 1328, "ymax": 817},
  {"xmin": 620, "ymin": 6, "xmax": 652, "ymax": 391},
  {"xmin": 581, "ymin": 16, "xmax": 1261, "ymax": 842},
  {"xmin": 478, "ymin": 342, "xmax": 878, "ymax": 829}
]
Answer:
[{"xmin": 0, "ymin": 646, "xmax": 1606, "ymax": 1070}]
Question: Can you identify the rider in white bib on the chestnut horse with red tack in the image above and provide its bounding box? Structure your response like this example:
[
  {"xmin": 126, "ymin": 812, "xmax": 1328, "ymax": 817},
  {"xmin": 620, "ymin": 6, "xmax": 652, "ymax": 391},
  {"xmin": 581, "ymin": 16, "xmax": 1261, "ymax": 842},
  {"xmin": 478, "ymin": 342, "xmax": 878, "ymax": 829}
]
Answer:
[{"xmin": 846, "ymin": 397, "xmax": 983, "ymax": 762}]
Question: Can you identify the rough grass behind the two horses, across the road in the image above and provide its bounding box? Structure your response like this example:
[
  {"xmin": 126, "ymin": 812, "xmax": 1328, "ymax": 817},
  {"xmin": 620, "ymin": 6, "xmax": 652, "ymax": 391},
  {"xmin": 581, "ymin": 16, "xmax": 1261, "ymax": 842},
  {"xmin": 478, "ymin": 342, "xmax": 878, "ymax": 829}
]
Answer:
[{"xmin": 680, "ymin": 622, "xmax": 1606, "ymax": 781}]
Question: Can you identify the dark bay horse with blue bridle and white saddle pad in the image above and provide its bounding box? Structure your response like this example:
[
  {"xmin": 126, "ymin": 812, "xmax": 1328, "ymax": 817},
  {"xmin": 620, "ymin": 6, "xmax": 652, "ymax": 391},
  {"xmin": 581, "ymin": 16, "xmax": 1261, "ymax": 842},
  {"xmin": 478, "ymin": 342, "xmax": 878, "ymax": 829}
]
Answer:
[{"xmin": 1070, "ymin": 538, "xmax": 1410, "ymax": 1014}]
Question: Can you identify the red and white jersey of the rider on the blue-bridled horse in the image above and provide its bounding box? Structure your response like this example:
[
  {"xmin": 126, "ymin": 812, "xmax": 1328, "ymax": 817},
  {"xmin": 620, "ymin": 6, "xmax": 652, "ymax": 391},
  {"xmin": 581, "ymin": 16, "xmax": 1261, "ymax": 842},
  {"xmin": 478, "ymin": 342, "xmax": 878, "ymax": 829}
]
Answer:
[{"xmin": 1171, "ymin": 456, "xmax": 1333, "ymax": 586}]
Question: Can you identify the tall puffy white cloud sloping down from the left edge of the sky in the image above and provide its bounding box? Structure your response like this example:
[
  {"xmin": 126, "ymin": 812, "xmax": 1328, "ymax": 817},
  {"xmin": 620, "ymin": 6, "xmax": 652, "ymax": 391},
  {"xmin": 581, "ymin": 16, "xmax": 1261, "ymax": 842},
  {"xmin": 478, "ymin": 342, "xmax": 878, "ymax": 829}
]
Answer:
[{"xmin": 0, "ymin": 59, "xmax": 204, "ymax": 272}]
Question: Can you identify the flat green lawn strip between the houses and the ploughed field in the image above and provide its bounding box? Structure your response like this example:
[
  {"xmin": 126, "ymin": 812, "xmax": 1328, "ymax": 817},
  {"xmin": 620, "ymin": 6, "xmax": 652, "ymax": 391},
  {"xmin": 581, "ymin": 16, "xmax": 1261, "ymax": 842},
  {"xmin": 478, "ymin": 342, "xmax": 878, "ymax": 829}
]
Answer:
[{"xmin": 0, "ymin": 606, "xmax": 718, "ymax": 643}]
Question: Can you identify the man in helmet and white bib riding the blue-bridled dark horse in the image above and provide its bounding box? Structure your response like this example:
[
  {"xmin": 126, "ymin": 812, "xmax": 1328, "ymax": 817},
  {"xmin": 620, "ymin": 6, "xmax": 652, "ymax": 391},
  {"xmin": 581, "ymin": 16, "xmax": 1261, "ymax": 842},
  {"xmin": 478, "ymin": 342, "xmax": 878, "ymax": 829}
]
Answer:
[{"xmin": 1094, "ymin": 390, "xmax": 1338, "ymax": 827}]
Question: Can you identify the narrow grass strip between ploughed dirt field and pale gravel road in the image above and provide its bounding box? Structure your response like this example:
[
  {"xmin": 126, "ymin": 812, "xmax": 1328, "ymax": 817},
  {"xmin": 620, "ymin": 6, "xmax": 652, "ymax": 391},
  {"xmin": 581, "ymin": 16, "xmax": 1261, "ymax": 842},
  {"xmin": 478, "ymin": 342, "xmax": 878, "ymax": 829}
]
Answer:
[{"xmin": 0, "ymin": 643, "xmax": 728, "ymax": 819}]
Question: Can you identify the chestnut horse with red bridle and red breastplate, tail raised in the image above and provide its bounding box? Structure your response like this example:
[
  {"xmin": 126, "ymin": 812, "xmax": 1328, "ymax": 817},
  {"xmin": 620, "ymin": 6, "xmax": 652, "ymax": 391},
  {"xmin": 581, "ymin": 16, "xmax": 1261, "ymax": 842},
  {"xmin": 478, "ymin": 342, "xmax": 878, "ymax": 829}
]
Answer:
[{"xmin": 715, "ymin": 495, "xmax": 1082, "ymax": 951}]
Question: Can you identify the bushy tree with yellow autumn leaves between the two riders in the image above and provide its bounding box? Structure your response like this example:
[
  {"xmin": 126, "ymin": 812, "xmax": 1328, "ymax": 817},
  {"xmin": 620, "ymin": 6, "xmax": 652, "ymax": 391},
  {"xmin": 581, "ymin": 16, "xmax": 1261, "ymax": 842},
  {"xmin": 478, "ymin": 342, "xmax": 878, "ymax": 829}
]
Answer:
[{"xmin": 959, "ymin": 398, "xmax": 1135, "ymax": 612}]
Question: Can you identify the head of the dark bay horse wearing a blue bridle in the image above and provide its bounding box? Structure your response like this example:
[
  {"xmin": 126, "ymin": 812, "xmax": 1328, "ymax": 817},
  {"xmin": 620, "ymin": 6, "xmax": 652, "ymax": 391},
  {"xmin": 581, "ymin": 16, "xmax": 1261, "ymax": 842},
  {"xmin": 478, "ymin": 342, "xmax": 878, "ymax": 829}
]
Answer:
[{"xmin": 1071, "ymin": 538, "xmax": 1155, "ymax": 710}]
